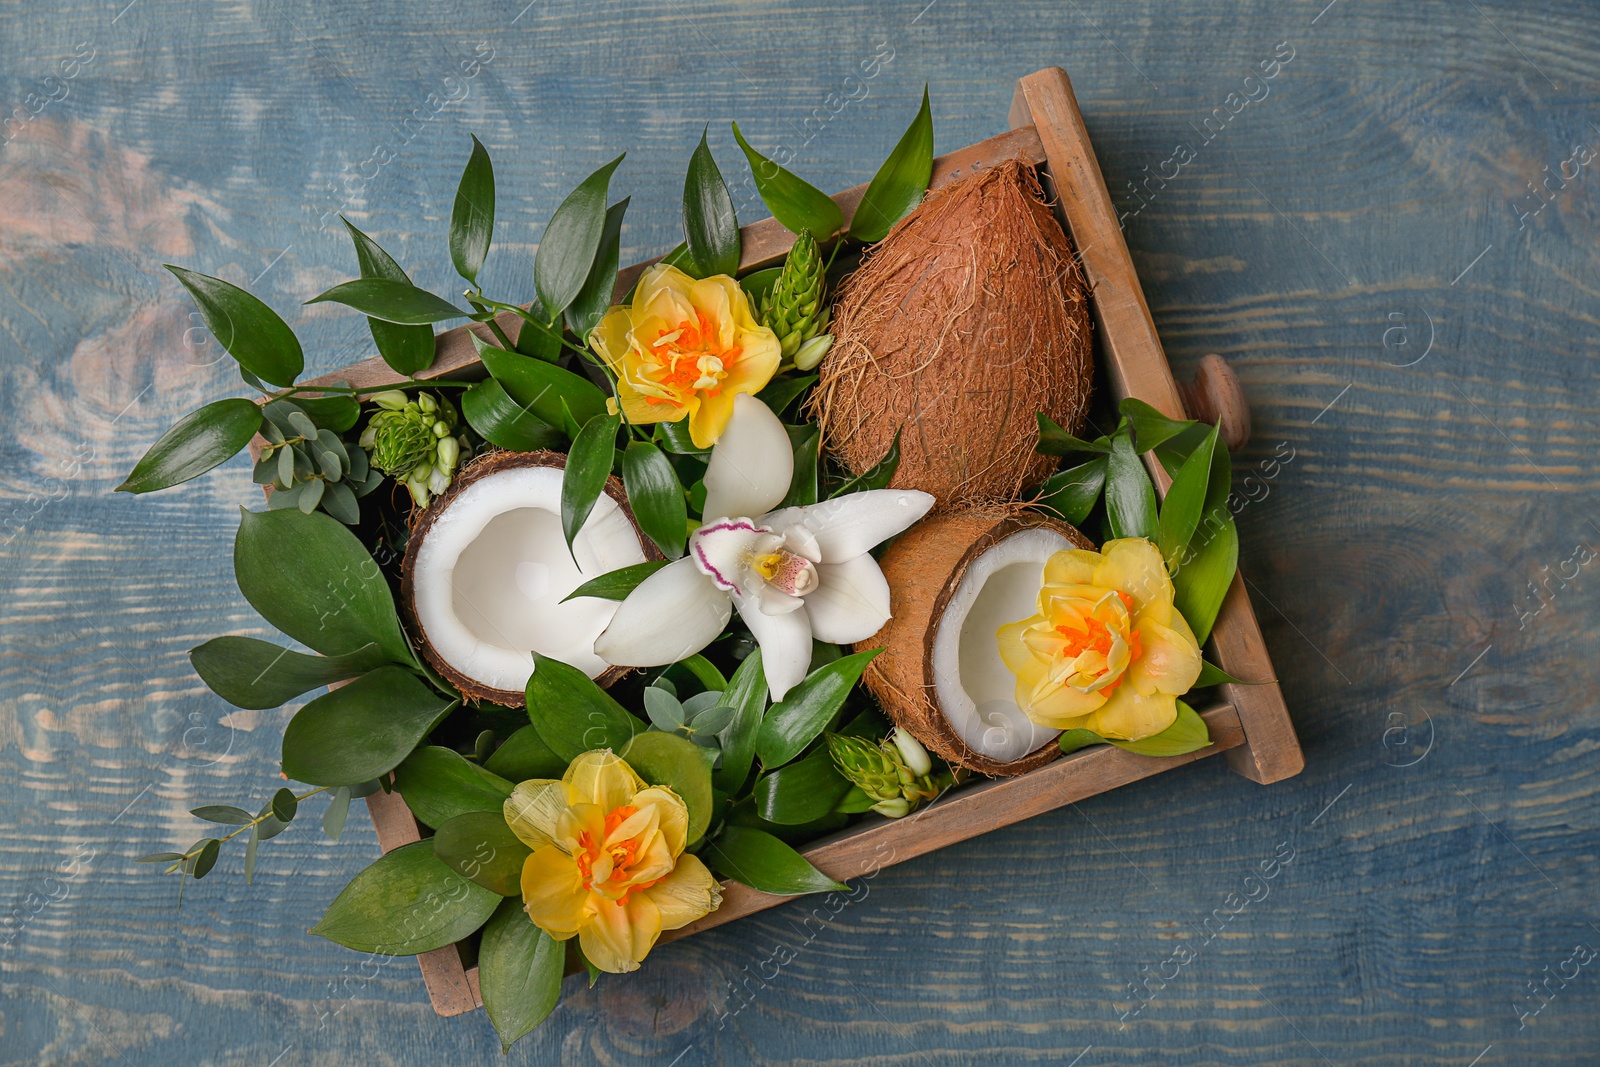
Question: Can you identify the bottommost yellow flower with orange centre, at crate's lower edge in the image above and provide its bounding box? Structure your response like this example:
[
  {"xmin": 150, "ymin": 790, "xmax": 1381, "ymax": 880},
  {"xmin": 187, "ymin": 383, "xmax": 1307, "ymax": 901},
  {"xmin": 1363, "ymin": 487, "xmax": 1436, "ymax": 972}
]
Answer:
[{"xmin": 506, "ymin": 749, "xmax": 722, "ymax": 974}]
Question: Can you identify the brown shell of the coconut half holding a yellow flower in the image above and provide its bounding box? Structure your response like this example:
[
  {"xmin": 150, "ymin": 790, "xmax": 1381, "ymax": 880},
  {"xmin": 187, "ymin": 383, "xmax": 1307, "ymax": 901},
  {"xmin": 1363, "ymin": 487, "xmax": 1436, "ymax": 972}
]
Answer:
[{"xmin": 856, "ymin": 506, "xmax": 1094, "ymax": 774}]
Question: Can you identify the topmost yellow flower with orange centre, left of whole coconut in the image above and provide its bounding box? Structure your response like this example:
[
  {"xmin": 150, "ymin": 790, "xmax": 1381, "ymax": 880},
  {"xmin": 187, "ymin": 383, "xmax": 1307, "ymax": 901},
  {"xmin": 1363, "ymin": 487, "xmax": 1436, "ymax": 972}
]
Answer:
[{"xmin": 589, "ymin": 264, "xmax": 782, "ymax": 448}]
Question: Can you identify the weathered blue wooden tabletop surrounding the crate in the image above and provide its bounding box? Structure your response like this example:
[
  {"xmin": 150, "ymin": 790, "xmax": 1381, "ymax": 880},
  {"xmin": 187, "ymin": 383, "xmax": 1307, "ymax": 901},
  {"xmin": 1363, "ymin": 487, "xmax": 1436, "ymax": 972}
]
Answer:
[{"xmin": 0, "ymin": 0, "xmax": 1600, "ymax": 1067}]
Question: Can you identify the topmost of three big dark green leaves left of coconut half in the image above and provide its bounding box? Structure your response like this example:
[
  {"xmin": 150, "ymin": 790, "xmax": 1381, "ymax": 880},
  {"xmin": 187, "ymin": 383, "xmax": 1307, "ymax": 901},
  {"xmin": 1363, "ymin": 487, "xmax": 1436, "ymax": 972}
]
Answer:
[{"xmin": 234, "ymin": 510, "xmax": 413, "ymax": 662}]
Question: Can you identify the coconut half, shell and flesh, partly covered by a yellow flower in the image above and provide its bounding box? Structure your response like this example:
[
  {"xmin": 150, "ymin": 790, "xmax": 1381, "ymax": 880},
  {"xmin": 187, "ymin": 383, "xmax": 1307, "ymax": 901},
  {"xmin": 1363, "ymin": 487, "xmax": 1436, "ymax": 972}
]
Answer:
[{"xmin": 856, "ymin": 507, "xmax": 1094, "ymax": 774}]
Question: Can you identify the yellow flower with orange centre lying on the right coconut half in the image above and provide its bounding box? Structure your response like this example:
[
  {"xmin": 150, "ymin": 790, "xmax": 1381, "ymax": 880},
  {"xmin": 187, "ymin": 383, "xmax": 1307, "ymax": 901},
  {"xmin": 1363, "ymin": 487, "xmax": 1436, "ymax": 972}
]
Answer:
[{"xmin": 997, "ymin": 537, "xmax": 1200, "ymax": 741}]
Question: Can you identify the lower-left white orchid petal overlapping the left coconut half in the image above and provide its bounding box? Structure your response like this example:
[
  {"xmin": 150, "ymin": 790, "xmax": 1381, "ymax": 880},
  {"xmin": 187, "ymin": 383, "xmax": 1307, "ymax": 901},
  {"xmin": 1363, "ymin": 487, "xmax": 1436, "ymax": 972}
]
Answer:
[{"xmin": 595, "ymin": 557, "xmax": 733, "ymax": 667}]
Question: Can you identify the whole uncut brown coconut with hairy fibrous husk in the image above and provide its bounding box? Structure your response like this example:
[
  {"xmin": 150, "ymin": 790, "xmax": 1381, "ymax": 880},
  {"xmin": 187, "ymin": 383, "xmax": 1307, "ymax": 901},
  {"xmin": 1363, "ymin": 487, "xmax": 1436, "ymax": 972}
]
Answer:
[{"xmin": 813, "ymin": 160, "xmax": 1094, "ymax": 507}]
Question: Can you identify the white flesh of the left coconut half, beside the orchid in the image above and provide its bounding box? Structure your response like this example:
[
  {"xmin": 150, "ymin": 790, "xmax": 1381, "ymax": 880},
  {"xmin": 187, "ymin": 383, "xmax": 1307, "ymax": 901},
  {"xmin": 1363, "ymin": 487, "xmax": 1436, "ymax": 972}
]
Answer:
[{"xmin": 411, "ymin": 467, "xmax": 645, "ymax": 691}]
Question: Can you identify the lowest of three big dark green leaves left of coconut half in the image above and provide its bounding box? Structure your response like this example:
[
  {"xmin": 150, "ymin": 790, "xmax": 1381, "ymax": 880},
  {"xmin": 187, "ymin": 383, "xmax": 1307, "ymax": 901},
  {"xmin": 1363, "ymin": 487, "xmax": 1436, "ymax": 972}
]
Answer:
[{"xmin": 283, "ymin": 667, "xmax": 456, "ymax": 785}]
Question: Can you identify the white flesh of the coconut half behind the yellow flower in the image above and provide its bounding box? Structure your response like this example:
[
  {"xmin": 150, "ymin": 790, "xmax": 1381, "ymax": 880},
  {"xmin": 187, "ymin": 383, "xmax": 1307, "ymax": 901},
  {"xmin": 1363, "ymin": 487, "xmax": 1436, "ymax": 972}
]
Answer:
[{"xmin": 933, "ymin": 526, "xmax": 1078, "ymax": 763}]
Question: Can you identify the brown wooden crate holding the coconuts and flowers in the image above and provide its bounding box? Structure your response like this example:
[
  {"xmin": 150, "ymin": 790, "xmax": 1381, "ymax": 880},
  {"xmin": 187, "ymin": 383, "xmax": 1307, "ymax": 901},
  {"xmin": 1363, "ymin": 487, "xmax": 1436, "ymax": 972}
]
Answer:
[{"xmin": 300, "ymin": 67, "xmax": 1304, "ymax": 1016}]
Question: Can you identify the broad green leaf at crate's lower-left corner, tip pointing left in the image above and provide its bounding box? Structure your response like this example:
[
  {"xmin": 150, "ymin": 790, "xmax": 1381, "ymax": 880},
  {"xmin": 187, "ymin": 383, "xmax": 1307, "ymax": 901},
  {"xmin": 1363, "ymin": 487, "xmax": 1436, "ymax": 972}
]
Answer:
[{"xmin": 310, "ymin": 841, "xmax": 501, "ymax": 957}]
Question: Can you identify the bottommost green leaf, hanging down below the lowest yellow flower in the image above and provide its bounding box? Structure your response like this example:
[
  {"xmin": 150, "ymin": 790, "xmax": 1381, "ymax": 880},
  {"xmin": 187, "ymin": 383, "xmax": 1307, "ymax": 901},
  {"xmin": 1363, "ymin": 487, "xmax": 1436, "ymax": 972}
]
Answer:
[{"xmin": 478, "ymin": 901, "xmax": 566, "ymax": 1053}]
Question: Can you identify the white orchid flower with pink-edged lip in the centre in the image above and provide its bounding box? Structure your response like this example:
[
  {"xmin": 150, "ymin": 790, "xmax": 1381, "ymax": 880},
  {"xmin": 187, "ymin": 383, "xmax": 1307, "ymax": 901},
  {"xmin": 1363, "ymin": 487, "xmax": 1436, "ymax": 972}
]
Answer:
[{"xmin": 595, "ymin": 394, "xmax": 933, "ymax": 701}]
